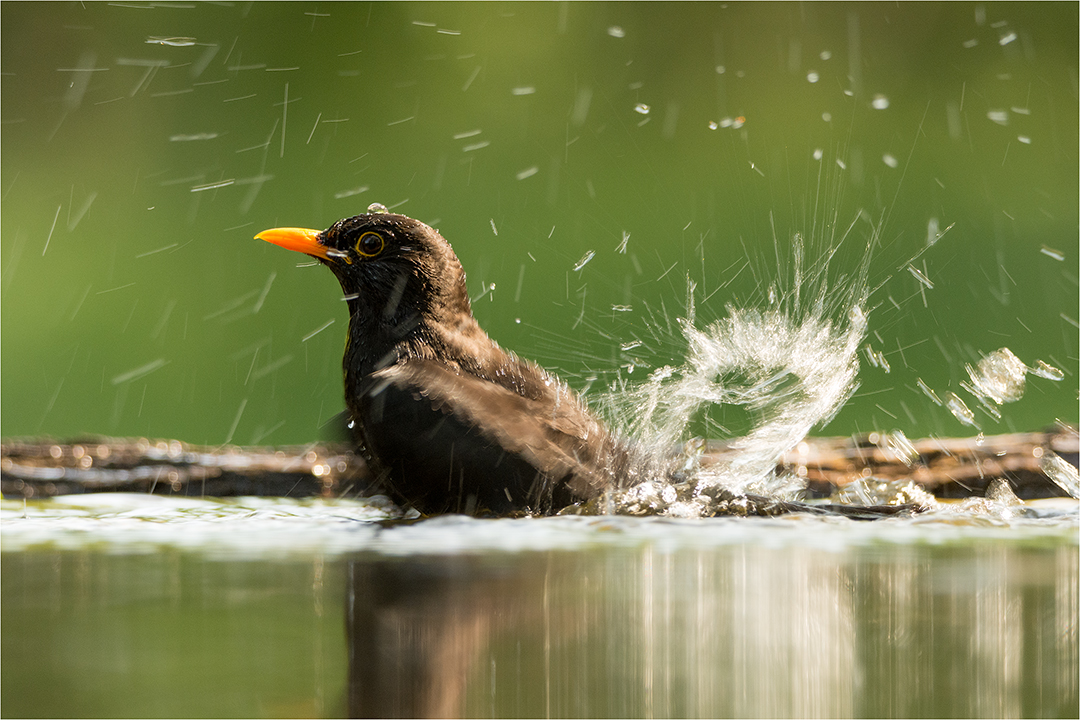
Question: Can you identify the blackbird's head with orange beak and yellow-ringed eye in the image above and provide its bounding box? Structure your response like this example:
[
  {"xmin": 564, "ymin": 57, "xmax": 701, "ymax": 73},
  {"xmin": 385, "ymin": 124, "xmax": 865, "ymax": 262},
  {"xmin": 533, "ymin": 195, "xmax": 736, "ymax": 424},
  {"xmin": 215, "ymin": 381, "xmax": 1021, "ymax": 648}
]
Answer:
[{"xmin": 256, "ymin": 204, "xmax": 472, "ymax": 328}]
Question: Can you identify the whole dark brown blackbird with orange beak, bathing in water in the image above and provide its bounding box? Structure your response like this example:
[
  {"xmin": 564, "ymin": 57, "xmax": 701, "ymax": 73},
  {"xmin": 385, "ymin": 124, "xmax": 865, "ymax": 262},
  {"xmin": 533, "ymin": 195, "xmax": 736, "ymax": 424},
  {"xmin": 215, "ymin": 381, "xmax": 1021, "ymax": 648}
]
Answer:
[{"xmin": 256, "ymin": 203, "xmax": 630, "ymax": 515}]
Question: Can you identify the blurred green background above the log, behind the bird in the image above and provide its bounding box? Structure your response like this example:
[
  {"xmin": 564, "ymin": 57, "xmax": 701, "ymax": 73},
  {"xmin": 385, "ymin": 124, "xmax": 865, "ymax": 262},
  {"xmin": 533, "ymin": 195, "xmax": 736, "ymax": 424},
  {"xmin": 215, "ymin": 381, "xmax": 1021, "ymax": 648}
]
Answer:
[{"xmin": 0, "ymin": 2, "xmax": 1078, "ymax": 445}]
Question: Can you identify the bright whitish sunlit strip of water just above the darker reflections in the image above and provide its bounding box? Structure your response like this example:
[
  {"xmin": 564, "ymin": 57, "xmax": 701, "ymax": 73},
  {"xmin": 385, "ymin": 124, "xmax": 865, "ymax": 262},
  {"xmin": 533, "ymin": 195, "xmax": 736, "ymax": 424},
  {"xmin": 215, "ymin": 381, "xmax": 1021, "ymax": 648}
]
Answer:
[{"xmin": 0, "ymin": 493, "xmax": 1080, "ymax": 559}]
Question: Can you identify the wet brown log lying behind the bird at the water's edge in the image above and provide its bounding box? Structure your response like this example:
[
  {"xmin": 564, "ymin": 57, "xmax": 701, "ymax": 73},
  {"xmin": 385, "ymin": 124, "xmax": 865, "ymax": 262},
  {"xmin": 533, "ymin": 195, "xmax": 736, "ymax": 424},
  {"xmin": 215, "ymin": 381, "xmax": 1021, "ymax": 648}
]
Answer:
[{"xmin": 0, "ymin": 425, "xmax": 1080, "ymax": 500}]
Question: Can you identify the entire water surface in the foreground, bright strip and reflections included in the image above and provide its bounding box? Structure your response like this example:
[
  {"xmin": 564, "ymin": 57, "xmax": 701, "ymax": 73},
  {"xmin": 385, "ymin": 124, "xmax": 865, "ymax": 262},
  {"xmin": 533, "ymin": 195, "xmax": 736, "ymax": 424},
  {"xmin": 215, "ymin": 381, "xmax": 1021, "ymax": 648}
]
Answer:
[{"xmin": 0, "ymin": 494, "xmax": 1080, "ymax": 717}]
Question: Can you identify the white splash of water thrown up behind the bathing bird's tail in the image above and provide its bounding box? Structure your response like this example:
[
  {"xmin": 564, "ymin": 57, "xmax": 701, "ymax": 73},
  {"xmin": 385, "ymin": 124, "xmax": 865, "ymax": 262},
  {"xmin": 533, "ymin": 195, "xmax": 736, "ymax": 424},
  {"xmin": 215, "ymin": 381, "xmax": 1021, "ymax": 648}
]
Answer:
[{"xmin": 605, "ymin": 226, "xmax": 877, "ymax": 516}]
